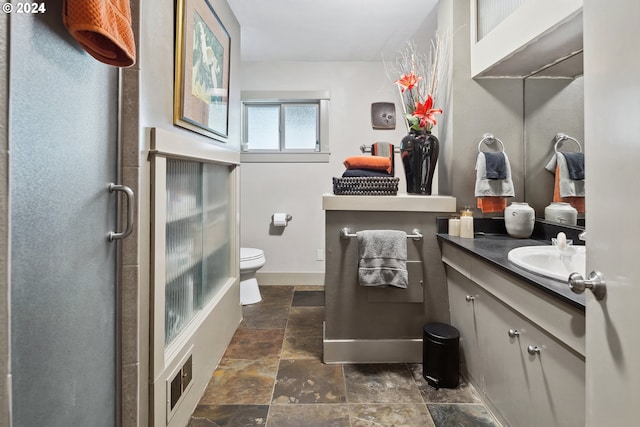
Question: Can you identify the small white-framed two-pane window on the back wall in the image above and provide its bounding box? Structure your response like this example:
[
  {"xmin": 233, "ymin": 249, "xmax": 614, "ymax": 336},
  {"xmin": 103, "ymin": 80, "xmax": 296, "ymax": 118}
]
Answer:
[{"xmin": 242, "ymin": 92, "xmax": 329, "ymax": 162}]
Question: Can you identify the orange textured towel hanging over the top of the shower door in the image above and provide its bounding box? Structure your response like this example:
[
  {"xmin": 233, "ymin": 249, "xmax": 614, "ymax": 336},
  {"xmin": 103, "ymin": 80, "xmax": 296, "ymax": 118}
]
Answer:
[{"xmin": 62, "ymin": 0, "xmax": 136, "ymax": 67}]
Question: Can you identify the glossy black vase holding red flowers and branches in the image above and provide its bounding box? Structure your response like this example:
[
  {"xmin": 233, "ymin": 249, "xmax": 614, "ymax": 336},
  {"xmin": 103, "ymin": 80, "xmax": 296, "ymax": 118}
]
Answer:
[{"xmin": 400, "ymin": 130, "xmax": 440, "ymax": 195}]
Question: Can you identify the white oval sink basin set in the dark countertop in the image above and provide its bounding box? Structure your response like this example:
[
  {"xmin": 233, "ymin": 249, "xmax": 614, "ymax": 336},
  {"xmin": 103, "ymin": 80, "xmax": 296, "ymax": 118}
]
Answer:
[{"xmin": 507, "ymin": 246, "xmax": 586, "ymax": 282}]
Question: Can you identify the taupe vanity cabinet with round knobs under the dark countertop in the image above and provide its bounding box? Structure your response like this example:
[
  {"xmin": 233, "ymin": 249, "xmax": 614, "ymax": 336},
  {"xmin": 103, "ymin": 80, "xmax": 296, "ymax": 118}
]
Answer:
[{"xmin": 442, "ymin": 243, "xmax": 585, "ymax": 427}]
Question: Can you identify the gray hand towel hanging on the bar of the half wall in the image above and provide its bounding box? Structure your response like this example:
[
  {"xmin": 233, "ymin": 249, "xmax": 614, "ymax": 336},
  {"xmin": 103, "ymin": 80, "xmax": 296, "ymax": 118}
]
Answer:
[{"xmin": 356, "ymin": 230, "xmax": 409, "ymax": 288}]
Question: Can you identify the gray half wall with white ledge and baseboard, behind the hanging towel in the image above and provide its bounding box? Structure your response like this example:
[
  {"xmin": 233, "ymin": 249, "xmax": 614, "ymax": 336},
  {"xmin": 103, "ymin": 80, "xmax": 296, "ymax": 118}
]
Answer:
[{"xmin": 322, "ymin": 194, "xmax": 456, "ymax": 363}]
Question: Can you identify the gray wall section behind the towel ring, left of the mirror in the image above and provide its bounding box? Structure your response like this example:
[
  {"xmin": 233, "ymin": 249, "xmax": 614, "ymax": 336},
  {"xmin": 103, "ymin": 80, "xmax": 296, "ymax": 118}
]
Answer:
[{"xmin": 438, "ymin": 0, "xmax": 524, "ymax": 216}]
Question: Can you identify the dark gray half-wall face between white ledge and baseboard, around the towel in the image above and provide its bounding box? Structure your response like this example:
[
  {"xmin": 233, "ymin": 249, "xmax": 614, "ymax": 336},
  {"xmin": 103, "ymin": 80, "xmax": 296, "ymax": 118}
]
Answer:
[{"xmin": 325, "ymin": 211, "xmax": 449, "ymax": 339}]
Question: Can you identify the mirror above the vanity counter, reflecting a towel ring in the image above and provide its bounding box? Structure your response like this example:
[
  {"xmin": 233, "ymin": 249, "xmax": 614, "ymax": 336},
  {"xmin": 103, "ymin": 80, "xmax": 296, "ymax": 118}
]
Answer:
[{"xmin": 524, "ymin": 52, "xmax": 585, "ymax": 224}]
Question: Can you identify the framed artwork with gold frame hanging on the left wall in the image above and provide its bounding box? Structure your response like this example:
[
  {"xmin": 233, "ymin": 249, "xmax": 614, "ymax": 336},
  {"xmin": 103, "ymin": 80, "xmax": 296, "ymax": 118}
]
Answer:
[{"xmin": 173, "ymin": 0, "xmax": 231, "ymax": 139}]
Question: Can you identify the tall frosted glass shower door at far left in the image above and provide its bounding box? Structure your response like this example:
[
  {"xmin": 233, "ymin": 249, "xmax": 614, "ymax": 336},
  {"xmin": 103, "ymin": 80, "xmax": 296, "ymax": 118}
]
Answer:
[{"xmin": 9, "ymin": 7, "xmax": 118, "ymax": 427}]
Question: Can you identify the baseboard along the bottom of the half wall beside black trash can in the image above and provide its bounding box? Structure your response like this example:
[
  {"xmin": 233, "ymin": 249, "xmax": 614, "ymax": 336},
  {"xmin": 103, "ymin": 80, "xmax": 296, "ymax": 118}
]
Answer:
[{"xmin": 322, "ymin": 327, "xmax": 422, "ymax": 364}]
